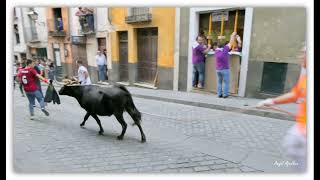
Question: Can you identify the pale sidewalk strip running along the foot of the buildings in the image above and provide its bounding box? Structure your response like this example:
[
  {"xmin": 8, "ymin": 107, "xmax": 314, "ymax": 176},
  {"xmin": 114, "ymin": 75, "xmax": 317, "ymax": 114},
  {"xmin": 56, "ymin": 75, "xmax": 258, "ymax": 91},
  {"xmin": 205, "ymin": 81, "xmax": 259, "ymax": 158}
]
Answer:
[{"xmin": 50, "ymin": 81, "xmax": 297, "ymax": 121}]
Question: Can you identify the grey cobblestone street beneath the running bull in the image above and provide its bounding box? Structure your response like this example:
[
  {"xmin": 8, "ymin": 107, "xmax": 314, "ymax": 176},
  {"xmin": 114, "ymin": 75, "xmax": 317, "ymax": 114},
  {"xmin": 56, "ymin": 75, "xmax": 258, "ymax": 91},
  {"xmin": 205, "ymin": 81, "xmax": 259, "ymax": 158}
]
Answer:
[{"xmin": 13, "ymin": 88, "xmax": 294, "ymax": 173}]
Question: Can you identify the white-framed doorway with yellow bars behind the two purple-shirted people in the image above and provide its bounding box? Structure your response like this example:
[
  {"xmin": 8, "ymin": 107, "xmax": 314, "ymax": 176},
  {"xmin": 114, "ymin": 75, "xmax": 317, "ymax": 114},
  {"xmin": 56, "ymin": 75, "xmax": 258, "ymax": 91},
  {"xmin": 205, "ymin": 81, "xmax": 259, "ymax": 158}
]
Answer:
[{"xmin": 187, "ymin": 8, "xmax": 252, "ymax": 97}]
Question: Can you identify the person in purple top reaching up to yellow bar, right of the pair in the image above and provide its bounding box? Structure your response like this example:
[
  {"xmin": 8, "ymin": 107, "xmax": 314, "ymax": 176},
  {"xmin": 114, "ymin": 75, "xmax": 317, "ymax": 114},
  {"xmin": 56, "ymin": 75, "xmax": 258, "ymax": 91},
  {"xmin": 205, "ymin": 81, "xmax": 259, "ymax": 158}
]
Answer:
[{"xmin": 214, "ymin": 35, "xmax": 234, "ymax": 98}]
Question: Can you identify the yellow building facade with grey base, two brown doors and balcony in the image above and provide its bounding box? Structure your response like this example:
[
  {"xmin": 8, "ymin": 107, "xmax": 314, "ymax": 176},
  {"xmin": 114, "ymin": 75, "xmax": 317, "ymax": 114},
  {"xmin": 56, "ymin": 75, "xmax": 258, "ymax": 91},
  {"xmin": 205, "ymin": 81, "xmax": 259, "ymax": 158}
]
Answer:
[{"xmin": 110, "ymin": 8, "xmax": 176, "ymax": 89}]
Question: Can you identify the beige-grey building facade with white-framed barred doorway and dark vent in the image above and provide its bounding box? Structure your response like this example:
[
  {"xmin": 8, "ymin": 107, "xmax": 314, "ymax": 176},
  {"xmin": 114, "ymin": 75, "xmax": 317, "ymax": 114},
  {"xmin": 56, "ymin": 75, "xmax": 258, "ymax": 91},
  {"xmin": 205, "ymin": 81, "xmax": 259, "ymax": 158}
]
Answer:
[{"xmin": 186, "ymin": 7, "xmax": 306, "ymax": 98}]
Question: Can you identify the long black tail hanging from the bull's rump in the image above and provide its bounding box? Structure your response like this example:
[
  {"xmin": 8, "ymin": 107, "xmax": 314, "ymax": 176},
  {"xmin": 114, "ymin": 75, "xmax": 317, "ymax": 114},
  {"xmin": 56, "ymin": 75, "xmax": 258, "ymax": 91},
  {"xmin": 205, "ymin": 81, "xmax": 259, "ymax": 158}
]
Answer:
[{"xmin": 117, "ymin": 84, "xmax": 141, "ymax": 125}]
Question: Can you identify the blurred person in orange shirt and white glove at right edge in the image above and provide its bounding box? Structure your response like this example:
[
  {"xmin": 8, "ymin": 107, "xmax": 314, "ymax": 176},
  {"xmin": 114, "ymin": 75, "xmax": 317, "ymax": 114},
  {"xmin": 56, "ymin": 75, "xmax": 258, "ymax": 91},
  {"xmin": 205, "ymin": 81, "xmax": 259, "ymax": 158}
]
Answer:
[{"xmin": 257, "ymin": 47, "xmax": 307, "ymax": 171}]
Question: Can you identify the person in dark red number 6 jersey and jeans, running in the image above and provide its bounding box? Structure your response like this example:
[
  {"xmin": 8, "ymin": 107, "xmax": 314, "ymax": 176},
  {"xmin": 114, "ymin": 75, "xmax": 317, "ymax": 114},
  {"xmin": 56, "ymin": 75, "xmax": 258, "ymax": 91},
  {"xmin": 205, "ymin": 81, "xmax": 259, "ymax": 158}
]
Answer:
[{"xmin": 17, "ymin": 59, "xmax": 49, "ymax": 120}]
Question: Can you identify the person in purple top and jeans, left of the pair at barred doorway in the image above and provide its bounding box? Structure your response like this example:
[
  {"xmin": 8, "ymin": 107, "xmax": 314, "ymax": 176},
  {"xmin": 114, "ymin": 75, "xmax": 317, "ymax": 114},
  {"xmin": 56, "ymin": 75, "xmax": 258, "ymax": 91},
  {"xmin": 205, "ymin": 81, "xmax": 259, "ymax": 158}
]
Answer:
[{"xmin": 192, "ymin": 35, "xmax": 211, "ymax": 89}]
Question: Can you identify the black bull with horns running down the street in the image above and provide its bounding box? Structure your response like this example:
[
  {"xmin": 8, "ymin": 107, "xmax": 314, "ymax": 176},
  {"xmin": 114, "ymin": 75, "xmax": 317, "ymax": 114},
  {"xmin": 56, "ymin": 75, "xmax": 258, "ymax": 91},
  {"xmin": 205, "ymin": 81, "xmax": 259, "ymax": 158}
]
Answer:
[{"xmin": 59, "ymin": 84, "xmax": 146, "ymax": 142}]
